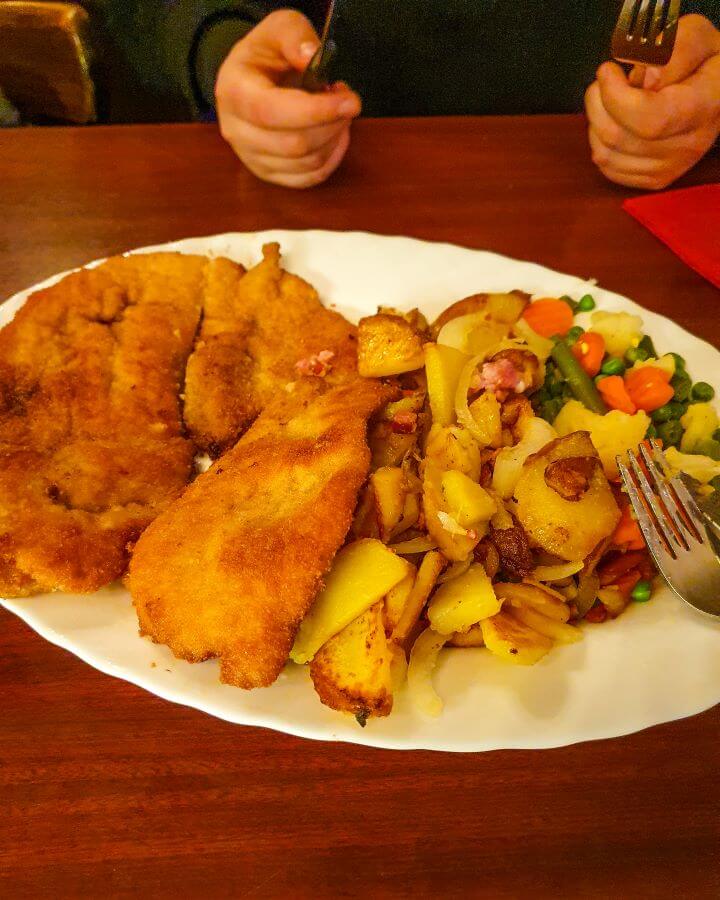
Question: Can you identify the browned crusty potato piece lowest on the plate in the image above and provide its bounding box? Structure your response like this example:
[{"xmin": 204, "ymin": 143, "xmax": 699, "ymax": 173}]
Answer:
[{"xmin": 310, "ymin": 603, "xmax": 397, "ymax": 725}]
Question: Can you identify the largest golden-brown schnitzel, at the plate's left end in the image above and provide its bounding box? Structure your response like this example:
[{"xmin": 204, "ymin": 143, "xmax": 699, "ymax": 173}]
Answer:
[{"xmin": 0, "ymin": 253, "xmax": 207, "ymax": 596}]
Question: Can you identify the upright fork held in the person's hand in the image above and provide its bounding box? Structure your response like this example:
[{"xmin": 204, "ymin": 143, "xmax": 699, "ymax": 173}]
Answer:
[{"xmin": 610, "ymin": 0, "xmax": 680, "ymax": 87}]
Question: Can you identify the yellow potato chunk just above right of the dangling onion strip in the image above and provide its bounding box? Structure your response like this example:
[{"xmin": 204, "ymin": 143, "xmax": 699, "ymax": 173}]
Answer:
[{"xmin": 428, "ymin": 563, "xmax": 502, "ymax": 635}]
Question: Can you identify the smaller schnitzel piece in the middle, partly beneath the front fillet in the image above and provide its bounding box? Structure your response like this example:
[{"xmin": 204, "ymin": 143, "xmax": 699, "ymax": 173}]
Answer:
[{"xmin": 184, "ymin": 244, "xmax": 357, "ymax": 456}]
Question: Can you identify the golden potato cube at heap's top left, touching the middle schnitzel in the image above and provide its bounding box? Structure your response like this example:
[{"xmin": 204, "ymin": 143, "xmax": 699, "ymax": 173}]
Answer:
[{"xmin": 358, "ymin": 314, "xmax": 425, "ymax": 378}]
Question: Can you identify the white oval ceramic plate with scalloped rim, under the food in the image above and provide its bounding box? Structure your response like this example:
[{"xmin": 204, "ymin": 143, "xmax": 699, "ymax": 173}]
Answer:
[{"xmin": 0, "ymin": 231, "xmax": 720, "ymax": 751}]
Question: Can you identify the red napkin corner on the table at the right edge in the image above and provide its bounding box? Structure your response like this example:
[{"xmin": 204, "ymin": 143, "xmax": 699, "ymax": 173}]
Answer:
[{"xmin": 623, "ymin": 184, "xmax": 720, "ymax": 288}]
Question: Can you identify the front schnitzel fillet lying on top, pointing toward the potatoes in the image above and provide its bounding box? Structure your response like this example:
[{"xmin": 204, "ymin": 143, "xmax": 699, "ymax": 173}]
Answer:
[{"xmin": 128, "ymin": 379, "xmax": 392, "ymax": 688}]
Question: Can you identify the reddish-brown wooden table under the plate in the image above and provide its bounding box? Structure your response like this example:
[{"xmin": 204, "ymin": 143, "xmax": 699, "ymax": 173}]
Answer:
[{"xmin": 0, "ymin": 117, "xmax": 720, "ymax": 898}]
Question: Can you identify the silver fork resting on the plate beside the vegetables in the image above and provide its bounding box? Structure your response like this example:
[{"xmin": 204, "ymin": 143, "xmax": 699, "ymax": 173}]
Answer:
[{"xmin": 617, "ymin": 441, "xmax": 720, "ymax": 617}]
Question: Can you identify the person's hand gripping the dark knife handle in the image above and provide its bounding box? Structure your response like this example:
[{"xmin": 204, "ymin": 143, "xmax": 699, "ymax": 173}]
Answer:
[{"xmin": 215, "ymin": 10, "xmax": 361, "ymax": 188}]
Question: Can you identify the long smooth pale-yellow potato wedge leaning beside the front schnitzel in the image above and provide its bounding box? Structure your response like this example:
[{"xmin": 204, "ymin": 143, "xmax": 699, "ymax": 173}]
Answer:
[{"xmin": 290, "ymin": 538, "xmax": 408, "ymax": 664}]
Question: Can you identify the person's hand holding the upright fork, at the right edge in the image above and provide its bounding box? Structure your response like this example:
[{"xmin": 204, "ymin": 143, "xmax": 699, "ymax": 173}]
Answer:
[{"xmin": 585, "ymin": 15, "xmax": 720, "ymax": 190}]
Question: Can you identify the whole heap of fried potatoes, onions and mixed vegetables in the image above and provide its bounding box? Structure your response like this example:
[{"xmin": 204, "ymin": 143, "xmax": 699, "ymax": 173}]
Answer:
[{"xmin": 291, "ymin": 291, "xmax": 720, "ymax": 724}]
